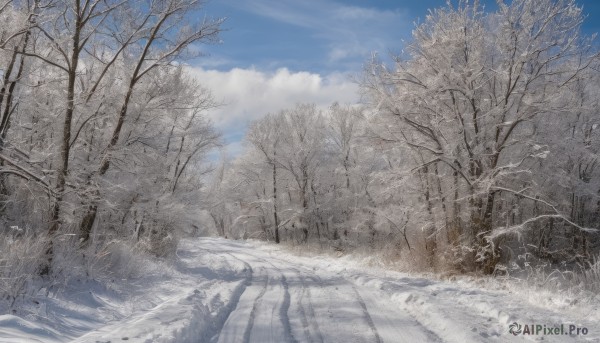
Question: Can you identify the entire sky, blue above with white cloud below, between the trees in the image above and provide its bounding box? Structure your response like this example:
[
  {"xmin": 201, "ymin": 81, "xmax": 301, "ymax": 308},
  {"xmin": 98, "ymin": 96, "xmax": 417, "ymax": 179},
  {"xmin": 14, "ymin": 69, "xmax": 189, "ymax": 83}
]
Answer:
[{"xmin": 190, "ymin": 0, "xmax": 600, "ymax": 156}]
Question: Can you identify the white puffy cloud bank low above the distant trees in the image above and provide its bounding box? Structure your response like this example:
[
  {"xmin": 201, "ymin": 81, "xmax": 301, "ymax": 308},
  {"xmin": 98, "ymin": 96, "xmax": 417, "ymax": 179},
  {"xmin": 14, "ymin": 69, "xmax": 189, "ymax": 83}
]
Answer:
[{"xmin": 188, "ymin": 67, "xmax": 359, "ymax": 155}]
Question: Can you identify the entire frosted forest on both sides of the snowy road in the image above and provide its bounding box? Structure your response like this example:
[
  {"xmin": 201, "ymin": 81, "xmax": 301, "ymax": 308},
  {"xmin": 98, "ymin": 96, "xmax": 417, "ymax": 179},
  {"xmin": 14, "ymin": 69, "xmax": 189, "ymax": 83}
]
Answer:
[{"xmin": 0, "ymin": 0, "xmax": 600, "ymax": 318}]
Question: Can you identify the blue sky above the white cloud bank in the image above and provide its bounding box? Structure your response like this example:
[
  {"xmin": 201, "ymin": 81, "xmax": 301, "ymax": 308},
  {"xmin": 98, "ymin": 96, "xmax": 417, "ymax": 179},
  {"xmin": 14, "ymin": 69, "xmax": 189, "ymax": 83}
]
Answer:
[{"xmin": 198, "ymin": 0, "xmax": 600, "ymax": 73}]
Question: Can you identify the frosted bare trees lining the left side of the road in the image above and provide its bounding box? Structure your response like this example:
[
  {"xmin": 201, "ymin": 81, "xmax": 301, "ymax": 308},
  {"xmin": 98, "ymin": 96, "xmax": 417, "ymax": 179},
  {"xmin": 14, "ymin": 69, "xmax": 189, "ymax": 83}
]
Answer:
[{"xmin": 0, "ymin": 0, "xmax": 222, "ymax": 306}]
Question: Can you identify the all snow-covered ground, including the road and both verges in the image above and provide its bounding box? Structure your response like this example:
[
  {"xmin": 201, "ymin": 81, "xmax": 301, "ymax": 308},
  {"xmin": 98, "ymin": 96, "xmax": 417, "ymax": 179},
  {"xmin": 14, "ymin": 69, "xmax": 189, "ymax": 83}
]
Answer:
[{"xmin": 0, "ymin": 238, "xmax": 600, "ymax": 343}]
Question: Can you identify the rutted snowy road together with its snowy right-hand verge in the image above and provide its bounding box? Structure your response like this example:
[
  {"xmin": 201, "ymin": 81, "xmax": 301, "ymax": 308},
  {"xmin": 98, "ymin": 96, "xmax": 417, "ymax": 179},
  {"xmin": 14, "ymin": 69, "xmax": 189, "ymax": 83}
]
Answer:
[{"xmin": 185, "ymin": 239, "xmax": 600, "ymax": 343}]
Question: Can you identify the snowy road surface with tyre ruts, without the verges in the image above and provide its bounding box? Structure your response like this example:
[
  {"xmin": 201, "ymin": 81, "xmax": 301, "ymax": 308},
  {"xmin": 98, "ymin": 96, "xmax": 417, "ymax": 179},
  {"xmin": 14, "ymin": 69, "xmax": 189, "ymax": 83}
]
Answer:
[{"xmin": 206, "ymin": 243, "xmax": 441, "ymax": 343}]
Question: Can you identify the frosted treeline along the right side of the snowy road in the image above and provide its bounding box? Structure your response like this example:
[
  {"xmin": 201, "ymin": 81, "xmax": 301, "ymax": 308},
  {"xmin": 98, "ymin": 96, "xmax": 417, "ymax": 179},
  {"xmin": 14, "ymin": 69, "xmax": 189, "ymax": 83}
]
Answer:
[{"xmin": 209, "ymin": 0, "xmax": 600, "ymax": 274}]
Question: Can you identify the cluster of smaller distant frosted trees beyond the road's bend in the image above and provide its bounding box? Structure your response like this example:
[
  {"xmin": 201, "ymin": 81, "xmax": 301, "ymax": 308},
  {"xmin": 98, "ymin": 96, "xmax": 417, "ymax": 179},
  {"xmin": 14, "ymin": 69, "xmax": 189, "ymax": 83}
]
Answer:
[{"xmin": 220, "ymin": 104, "xmax": 374, "ymax": 248}]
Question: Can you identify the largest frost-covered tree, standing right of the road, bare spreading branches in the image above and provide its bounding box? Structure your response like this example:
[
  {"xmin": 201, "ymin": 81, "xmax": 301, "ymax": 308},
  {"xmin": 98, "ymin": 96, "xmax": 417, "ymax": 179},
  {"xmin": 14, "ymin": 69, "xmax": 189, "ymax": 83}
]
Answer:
[{"xmin": 363, "ymin": 0, "xmax": 598, "ymax": 273}]
